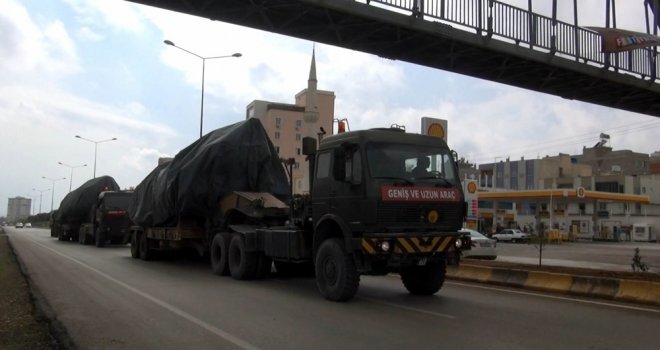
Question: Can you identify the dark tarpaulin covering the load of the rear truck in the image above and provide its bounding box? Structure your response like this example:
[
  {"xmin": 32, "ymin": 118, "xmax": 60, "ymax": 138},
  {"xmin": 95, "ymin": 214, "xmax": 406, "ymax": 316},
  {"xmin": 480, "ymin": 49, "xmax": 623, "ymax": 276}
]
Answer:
[{"xmin": 55, "ymin": 176, "xmax": 121, "ymax": 223}]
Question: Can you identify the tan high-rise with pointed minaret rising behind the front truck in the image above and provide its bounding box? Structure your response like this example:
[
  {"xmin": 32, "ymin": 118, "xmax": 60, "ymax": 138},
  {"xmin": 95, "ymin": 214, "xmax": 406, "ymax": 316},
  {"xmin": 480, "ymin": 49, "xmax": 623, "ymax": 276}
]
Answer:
[{"xmin": 246, "ymin": 48, "xmax": 335, "ymax": 194}]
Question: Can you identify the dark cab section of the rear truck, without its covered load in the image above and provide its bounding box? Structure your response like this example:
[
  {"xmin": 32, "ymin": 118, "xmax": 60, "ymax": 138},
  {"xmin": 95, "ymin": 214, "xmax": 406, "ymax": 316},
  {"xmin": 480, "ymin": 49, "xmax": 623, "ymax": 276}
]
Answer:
[{"xmin": 78, "ymin": 191, "xmax": 133, "ymax": 248}]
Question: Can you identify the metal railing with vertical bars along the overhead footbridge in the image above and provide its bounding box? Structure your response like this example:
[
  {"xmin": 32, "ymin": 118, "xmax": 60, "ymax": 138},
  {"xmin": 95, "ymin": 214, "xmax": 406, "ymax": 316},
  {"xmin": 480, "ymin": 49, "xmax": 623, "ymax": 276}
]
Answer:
[{"xmin": 367, "ymin": 0, "xmax": 660, "ymax": 82}]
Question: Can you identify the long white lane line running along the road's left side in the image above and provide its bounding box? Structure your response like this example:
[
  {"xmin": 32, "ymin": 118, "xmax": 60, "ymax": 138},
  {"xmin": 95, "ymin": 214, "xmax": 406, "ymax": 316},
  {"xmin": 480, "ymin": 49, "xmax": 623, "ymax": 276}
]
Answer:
[{"xmin": 21, "ymin": 238, "xmax": 260, "ymax": 350}]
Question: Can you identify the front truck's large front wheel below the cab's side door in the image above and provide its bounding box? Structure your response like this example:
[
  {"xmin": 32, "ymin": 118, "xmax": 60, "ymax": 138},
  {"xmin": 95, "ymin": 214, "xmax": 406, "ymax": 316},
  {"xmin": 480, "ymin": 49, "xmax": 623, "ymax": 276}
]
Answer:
[{"xmin": 316, "ymin": 238, "xmax": 360, "ymax": 301}]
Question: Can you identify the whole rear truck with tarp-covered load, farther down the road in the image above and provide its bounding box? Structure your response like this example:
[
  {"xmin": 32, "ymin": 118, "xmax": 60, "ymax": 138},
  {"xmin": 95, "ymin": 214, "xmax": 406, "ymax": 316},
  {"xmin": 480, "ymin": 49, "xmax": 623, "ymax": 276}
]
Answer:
[{"xmin": 51, "ymin": 176, "xmax": 132, "ymax": 247}]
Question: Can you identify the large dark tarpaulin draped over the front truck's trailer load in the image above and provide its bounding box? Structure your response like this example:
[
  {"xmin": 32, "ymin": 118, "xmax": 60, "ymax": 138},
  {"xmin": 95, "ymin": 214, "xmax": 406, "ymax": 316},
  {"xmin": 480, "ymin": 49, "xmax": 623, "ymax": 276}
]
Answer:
[{"xmin": 128, "ymin": 118, "xmax": 289, "ymax": 227}]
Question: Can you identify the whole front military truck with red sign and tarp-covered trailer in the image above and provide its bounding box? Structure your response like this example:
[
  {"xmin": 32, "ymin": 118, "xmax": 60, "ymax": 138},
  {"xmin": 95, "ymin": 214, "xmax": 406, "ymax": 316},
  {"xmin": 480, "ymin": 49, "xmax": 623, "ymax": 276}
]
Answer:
[{"xmin": 129, "ymin": 119, "xmax": 470, "ymax": 301}]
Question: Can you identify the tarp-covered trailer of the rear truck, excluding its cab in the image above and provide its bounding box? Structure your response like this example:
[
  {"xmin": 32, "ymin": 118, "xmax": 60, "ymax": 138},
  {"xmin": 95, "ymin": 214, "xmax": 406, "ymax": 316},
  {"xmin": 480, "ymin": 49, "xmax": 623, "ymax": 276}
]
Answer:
[{"xmin": 51, "ymin": 176, "xmax": 120, "ymax": 245}]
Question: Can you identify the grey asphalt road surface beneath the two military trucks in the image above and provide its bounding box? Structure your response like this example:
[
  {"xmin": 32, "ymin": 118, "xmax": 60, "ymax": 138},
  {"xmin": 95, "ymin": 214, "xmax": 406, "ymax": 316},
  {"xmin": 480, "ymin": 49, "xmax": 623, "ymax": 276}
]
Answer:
[{"xmin": 6, "ymin": 228, "xmax": 660, "ymax": 350}]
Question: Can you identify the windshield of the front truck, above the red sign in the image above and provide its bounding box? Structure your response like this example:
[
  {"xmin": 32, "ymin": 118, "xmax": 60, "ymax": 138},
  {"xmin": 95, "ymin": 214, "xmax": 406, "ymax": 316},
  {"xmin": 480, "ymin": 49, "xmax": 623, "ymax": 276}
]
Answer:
[{"xmin": 366, "ymin": 143, "xmax": 459, "ymax": 185}]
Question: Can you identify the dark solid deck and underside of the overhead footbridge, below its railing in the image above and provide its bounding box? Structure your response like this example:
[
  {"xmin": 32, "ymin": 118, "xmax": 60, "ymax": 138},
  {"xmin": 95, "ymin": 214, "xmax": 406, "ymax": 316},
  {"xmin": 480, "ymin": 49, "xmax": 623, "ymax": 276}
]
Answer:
[{"xmin": 130, "ymin": 0, "xmax": 660, "ymax": 117}]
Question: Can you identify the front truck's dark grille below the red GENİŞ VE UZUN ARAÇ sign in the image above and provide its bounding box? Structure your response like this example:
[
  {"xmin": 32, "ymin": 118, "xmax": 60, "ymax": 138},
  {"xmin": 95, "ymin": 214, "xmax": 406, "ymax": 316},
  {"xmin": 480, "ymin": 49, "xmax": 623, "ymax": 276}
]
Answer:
[{"xmin": 376, "ymin": 202, "xmax": 463, "ymax": 231}]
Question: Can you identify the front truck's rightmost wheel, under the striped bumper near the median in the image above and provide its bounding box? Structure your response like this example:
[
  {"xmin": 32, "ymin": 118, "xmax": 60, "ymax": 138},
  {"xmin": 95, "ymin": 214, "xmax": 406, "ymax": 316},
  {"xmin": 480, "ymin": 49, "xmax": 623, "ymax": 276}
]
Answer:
[{"xmin": 401, "ymin": 259, "xmax": 446, "ymax": 295}]
